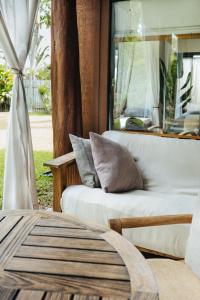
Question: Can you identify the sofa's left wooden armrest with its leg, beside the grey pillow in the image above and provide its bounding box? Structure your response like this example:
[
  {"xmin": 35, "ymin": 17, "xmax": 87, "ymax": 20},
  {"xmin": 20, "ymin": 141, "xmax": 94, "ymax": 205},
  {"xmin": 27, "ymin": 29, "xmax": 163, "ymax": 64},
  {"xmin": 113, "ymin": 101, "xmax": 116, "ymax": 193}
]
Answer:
[{"xmin": 44, "ymin": 152, "xmax": 81, "ymax": 211}]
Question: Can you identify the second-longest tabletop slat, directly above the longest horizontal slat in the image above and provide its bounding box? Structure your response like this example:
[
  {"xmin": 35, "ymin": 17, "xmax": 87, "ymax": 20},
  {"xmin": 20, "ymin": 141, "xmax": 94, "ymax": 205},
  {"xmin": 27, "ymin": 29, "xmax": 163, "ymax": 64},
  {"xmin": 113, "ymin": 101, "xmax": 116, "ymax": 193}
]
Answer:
[{"xmin": 15, "ymin": 246, "xmax": 124, "ymax": 265}]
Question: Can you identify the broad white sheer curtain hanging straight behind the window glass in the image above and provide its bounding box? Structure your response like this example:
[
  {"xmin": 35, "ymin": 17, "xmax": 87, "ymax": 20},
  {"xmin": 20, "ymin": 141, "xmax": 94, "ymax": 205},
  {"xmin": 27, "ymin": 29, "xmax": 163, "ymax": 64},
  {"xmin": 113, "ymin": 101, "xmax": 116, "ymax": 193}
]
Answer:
[{"xmin": 127, "ymin": 41, "xmax": 160, "ymax": 126}]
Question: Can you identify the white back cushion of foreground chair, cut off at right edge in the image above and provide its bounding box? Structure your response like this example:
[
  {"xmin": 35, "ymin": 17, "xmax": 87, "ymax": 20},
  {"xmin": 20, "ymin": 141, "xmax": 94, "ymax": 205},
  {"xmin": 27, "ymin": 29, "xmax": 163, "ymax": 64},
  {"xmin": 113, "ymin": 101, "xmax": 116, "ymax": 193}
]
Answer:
[{"xmin": 185, "ymin": 210, "xmax": 200, "ymax": 279}]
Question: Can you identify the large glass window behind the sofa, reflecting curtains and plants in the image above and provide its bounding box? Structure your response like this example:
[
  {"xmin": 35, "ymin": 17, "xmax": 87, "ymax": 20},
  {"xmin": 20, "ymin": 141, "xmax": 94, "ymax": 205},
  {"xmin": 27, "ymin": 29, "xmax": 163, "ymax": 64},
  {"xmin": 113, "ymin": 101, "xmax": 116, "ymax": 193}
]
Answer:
[{"xmin": 110, "ymin": 0, "xmax": 200, "ymax": 135}]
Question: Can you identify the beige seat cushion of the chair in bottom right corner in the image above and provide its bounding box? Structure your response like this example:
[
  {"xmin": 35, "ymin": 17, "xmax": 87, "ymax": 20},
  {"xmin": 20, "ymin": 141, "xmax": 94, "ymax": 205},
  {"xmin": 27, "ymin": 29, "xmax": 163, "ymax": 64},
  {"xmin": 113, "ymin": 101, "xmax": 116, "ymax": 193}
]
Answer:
[{"xmin": 147, "ymin": 259, "xmax": 200, "ymax": 300}]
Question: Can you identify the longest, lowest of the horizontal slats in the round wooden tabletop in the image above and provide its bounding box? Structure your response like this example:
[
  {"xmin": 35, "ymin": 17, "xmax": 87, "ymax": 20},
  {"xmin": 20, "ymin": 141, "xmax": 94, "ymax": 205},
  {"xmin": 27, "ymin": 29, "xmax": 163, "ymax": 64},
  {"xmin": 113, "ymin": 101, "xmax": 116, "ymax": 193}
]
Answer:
[{"xmin": 5, "ymin": 257, "xmax": 129, "ymax": 281}]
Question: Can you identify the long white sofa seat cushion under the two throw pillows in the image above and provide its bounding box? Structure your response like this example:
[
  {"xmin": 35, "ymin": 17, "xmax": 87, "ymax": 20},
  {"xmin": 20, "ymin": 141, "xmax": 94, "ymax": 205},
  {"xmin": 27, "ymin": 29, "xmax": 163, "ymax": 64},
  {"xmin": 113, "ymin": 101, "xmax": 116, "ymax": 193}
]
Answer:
[{"xmin": 61, "ymin": 185, "xmax": 199, "ymax": 257}]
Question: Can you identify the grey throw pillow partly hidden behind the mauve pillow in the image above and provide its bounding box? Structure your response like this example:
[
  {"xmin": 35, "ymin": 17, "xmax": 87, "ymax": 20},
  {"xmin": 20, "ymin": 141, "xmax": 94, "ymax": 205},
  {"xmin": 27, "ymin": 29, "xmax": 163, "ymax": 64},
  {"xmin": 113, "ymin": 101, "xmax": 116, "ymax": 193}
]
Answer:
[{"xmin": 69, "ymin": 134, "xmax": 100, "ymax": 188}]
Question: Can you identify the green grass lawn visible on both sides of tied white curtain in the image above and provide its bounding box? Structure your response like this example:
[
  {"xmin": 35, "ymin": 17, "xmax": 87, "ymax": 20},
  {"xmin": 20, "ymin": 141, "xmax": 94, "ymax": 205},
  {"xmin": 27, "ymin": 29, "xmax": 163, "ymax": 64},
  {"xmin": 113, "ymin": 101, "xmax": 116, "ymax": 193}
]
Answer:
[{"xmin": 0, "ymin": 150, "xmax": 53, "ymax": 208}]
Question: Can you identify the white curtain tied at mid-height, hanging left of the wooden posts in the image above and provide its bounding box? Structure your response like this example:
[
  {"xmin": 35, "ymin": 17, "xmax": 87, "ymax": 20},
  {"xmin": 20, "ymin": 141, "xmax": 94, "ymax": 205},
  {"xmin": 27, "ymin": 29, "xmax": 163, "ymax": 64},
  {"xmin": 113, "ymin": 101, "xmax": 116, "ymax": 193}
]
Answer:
[{"xmin": 0, "ymin": 0, "xmax": 39, "ymax": 209}]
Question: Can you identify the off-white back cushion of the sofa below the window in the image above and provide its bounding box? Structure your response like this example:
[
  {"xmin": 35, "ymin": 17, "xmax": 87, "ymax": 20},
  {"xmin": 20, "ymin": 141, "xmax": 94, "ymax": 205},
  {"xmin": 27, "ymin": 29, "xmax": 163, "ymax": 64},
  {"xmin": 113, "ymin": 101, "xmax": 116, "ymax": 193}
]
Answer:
[{"xmin": 103, "ymin": 131, "xmax": 200, "ymax": 195}]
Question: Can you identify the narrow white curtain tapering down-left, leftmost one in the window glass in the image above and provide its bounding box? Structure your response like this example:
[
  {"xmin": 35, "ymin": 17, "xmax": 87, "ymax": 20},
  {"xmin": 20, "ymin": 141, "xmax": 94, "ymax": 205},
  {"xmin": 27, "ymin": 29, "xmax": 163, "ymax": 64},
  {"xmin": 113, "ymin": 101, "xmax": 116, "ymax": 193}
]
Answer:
[{"xmin": 114, "ymin": 42, "xmax": 135, "ymax": 118}]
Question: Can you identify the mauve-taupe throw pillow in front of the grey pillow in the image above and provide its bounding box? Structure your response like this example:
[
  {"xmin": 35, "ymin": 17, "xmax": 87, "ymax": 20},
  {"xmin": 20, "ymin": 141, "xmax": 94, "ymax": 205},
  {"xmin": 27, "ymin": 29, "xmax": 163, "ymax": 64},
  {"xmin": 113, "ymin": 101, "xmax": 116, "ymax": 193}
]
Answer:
[{"xmin": 90, "ymin": 133, "xmax": 143, "ymax": 192}]
